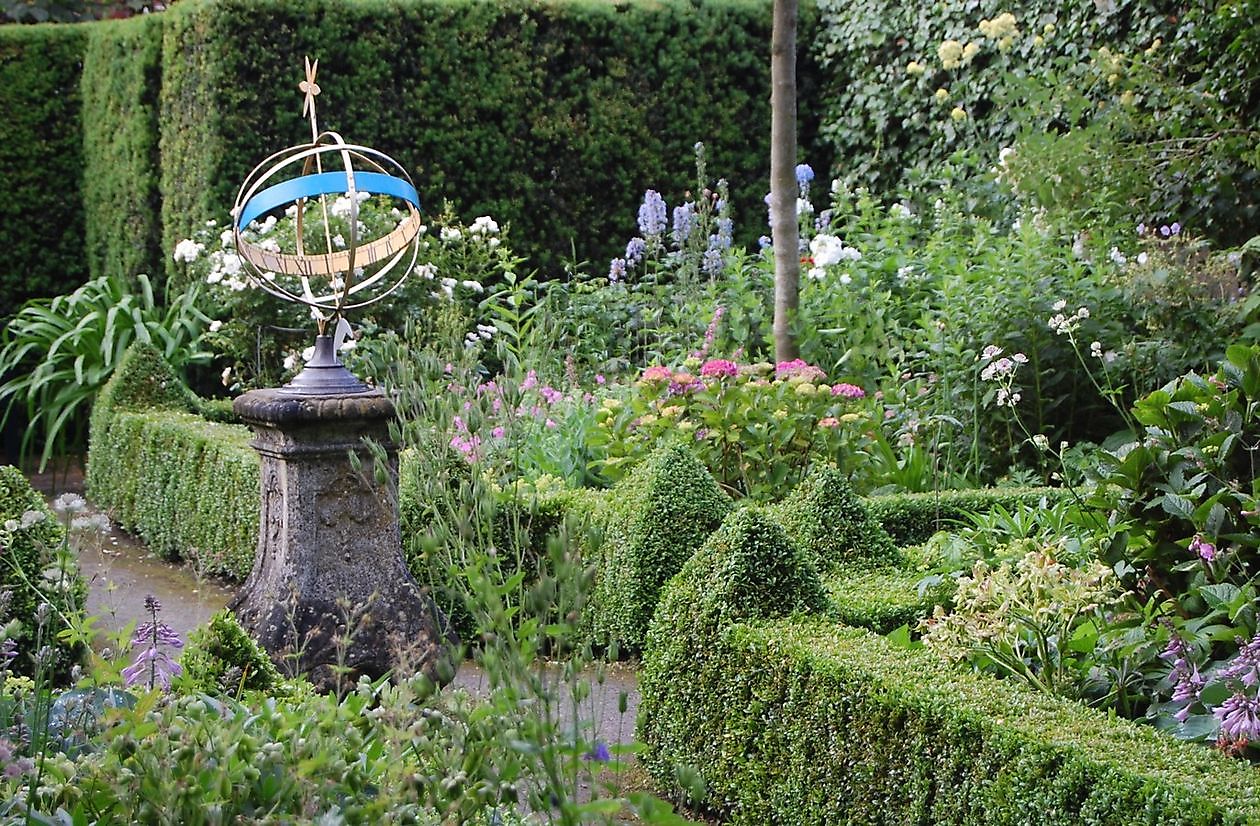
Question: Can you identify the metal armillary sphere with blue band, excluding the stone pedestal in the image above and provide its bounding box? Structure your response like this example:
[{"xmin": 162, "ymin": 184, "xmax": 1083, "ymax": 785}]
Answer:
[{"xmin": 232, "ymin": 58, "xmax": 422, "ymax": 394}]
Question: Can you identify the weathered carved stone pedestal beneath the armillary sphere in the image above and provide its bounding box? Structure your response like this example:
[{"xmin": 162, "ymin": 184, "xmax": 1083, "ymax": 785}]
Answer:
[{"xmin": 232, "ymin": 389, "xmax": 455, "ymax": 689}]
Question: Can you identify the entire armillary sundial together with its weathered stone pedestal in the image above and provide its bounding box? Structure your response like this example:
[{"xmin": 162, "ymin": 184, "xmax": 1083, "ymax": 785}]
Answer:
[{"xmin": 232, "ymin": 59, "xmax": 455, "ymax": 690}]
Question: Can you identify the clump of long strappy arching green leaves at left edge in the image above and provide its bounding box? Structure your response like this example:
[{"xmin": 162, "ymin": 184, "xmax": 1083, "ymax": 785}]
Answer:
[{"xmin": 0, "ymin": 274, "xmax": 209, "ymax": 467}]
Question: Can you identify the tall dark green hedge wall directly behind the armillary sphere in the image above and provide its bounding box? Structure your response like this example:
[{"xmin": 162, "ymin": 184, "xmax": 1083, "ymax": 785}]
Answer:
[{"xmin": 161, "ymin": 0, "xmax": 815, "ymax": 279}]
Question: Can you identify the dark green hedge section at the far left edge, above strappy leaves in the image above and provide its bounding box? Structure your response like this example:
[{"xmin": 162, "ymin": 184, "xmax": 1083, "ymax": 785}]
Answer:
[{"xmin": 0, "ymin": 24, "xmax": 87, "ymax": 321}]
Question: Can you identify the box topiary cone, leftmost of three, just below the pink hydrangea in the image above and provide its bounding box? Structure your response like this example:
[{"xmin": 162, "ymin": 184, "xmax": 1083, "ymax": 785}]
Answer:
[{"xmin": 592, "ymin": 446, "xmax": 731, "ymax": 652}]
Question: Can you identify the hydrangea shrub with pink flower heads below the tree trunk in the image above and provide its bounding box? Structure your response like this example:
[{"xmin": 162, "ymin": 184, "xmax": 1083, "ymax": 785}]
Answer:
[{"xmin": 592, "ymin": 359, "xmax": 871, "ymax": 500}]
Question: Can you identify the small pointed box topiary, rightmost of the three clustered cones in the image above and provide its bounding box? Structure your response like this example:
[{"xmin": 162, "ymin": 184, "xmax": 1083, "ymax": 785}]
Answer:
[{"xmin": 770, "ymin": 467, "xmax": 901, "ymax": 574}]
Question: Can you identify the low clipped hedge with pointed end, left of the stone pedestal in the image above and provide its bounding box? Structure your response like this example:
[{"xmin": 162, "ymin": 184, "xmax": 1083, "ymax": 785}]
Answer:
[{"xmin": 86, "ymin": 348, "xmax": 260, "ymax": 580}]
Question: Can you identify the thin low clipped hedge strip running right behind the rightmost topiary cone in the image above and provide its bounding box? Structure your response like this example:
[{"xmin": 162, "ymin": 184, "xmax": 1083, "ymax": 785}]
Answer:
[{"xmin": 866, "ymin": 487, "xmax": 1070, "ymax": 546}]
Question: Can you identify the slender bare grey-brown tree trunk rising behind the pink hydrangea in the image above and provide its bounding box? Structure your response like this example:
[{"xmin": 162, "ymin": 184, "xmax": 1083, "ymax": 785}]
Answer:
[{"xmin": 770, "ymin": 0, "xmax": 800, "ymax": 361}]
